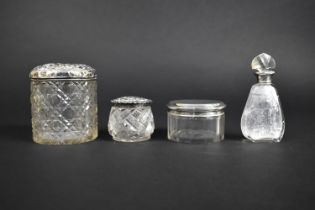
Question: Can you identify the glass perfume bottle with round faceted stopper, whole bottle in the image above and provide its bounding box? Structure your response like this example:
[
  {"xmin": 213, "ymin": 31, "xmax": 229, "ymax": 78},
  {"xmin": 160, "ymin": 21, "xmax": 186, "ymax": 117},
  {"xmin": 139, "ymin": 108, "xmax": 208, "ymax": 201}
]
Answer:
[{"xmin": 241, "ymin": 53, "xmax": 285, "ymax": 142}]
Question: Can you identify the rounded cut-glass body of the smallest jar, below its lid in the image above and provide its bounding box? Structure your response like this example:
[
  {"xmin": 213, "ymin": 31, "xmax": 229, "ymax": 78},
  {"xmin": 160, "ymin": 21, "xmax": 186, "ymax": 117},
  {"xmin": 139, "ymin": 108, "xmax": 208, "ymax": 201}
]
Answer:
[{"xmin": 108, "ymin": 104, "xmax": 154, "ymax": 142}]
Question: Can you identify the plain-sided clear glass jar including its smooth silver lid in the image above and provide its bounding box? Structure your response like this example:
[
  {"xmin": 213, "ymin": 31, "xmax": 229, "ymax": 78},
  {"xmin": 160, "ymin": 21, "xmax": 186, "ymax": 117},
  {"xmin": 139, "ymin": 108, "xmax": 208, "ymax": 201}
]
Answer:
[{"xmin": 167, "ymin": 100, "xmax": 225, "ymax": 143}]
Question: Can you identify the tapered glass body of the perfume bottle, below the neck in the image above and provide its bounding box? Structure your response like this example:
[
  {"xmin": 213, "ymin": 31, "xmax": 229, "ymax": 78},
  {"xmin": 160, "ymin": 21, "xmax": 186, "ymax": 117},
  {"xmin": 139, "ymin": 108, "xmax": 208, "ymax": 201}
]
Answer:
[{"xmin": 241, "ymin": 79, "xmax": 285, "ymax": 142}]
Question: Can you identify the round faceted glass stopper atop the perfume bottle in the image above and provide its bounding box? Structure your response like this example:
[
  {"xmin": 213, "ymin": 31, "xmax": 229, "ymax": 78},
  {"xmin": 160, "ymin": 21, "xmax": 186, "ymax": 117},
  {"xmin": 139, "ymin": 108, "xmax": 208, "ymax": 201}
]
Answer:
[{"xmin": 251, "ymin": 53, "xmax": 276, "ymax": 73}]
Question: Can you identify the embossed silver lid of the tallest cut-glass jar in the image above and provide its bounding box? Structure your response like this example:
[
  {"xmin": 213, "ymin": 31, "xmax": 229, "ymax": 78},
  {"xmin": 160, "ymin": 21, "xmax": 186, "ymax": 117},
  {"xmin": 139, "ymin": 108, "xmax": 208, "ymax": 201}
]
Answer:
[{"xmin": 30, "ymin": 63, "xmax": 96, "ymax": 79}]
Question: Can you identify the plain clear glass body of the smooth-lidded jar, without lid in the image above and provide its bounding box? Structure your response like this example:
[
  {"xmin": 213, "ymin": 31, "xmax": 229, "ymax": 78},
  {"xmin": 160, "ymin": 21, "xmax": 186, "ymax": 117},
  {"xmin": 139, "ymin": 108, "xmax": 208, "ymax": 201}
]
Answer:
[{"xmin": 167, "ymin": 110, "xmax": 225, "ymax": 143}]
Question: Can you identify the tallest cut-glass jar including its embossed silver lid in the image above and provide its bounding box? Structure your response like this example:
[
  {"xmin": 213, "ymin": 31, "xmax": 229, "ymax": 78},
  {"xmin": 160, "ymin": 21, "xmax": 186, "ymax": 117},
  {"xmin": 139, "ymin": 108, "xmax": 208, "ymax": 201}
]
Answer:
[{"xmin": 30, "ymin": 63, "xmax": 98, "ymax": 144}]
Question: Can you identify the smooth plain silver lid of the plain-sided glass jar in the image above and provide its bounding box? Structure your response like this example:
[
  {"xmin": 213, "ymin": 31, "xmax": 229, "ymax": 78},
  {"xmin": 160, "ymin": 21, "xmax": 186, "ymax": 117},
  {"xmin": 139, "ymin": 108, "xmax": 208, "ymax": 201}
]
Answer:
[{"xmin": 167, "ymin": 99, "xmax": 226, "ymax": 111}]
